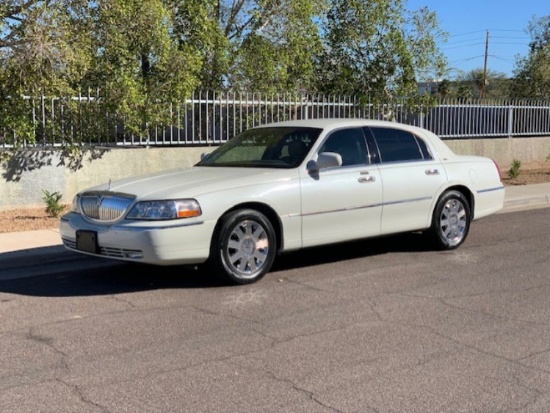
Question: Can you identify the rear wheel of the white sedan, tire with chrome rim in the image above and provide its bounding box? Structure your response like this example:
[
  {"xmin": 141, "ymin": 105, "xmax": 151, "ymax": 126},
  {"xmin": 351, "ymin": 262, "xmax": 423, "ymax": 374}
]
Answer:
[{"xmin": 431, "ymin": 190, "xmax": 472, "ymax": 250}]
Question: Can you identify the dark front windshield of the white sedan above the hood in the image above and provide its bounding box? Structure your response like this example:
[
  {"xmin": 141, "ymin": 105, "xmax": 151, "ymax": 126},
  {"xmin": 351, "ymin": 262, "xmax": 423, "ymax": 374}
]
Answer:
[{"xmin": 197, "ymin": 127, "xmax": 321, "ymax": 168}]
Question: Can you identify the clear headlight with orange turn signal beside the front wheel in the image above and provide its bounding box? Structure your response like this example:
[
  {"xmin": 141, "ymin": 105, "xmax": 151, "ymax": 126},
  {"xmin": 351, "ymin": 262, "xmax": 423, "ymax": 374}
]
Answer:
[{"xmin": 126, "ymin": 199, "xmax": 202, "ymax": 220}]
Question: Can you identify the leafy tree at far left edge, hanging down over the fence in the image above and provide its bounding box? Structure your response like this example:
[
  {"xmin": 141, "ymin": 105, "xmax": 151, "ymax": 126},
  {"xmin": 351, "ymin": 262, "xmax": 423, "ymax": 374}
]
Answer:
[{"xmin": 0, "ymin": 0, "xmax": 91, "ymax": 147}]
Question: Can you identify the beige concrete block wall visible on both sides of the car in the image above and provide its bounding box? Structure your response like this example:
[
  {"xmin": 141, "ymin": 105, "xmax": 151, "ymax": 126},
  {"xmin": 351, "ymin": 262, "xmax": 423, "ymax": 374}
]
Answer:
[{"xmin": 0, "ymin": 137, "xmax": 550, "ymax": 210}]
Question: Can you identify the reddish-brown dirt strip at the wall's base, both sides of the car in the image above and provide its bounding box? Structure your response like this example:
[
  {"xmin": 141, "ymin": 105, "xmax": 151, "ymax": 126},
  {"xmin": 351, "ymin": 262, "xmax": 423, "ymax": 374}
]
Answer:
[{"xmin": 0, "ymin": 165, "xmax": 550, "ymax": 232}]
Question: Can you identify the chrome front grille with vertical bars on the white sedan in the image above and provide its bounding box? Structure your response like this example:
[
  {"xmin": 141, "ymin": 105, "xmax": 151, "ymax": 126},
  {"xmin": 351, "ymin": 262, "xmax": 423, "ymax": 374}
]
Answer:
[{"xmin": 80, "ymin": 192, "xmax": 134, "ymax": 221}]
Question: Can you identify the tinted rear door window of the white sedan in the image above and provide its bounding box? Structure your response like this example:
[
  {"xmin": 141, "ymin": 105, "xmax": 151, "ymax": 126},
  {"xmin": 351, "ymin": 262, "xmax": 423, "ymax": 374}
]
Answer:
[{"xmin": 371, "ymin": 127, "xmax": 432, "ymax": 162}]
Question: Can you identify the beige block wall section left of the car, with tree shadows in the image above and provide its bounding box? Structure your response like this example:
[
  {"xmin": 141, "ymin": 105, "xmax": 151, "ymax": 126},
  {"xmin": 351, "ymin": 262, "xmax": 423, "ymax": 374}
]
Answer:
[{"xmin": 0, "ymin": 147, "xmax": 214, "ymax": 210}]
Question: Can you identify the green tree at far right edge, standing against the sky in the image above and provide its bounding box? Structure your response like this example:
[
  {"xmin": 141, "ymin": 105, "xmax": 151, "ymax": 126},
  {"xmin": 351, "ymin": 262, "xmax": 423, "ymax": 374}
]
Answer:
[{"xmin": 511, "ymin": 15, "xmax": 550, "ymax": 99}]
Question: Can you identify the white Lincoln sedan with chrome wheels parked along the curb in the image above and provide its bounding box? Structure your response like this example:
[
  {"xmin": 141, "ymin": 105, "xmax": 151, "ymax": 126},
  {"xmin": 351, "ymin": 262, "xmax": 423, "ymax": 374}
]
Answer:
[{"xmin": 60, "ymin": 119, "xmax": 504, "ymax": 284}]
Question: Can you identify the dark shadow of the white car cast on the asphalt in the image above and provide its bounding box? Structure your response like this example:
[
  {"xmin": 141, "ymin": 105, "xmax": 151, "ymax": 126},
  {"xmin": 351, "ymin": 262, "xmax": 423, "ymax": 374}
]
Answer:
[{"xmin": 0, "ymin": 234, "xmax": 430, "ymax": 297}]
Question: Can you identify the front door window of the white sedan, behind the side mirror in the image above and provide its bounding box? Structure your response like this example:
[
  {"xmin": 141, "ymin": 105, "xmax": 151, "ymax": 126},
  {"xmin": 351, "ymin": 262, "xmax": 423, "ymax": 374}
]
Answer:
[{"xmin": 319, "ymin": 128, "xmax": 368, "ymax": 166}]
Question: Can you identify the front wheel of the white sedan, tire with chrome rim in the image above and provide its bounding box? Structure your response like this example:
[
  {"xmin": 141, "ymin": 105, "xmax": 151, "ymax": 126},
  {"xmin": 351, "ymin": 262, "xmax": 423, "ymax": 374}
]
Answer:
[{"xmin": 210, "ymin": 209, "xmax": 277, "ymax": 284}]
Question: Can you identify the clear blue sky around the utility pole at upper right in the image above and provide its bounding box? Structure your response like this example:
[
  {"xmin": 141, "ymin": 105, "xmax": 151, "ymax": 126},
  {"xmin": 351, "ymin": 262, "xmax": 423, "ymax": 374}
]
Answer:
[{"xmin": 407, "ymin": 0, "xmax": 550, "ymax": 78}]
